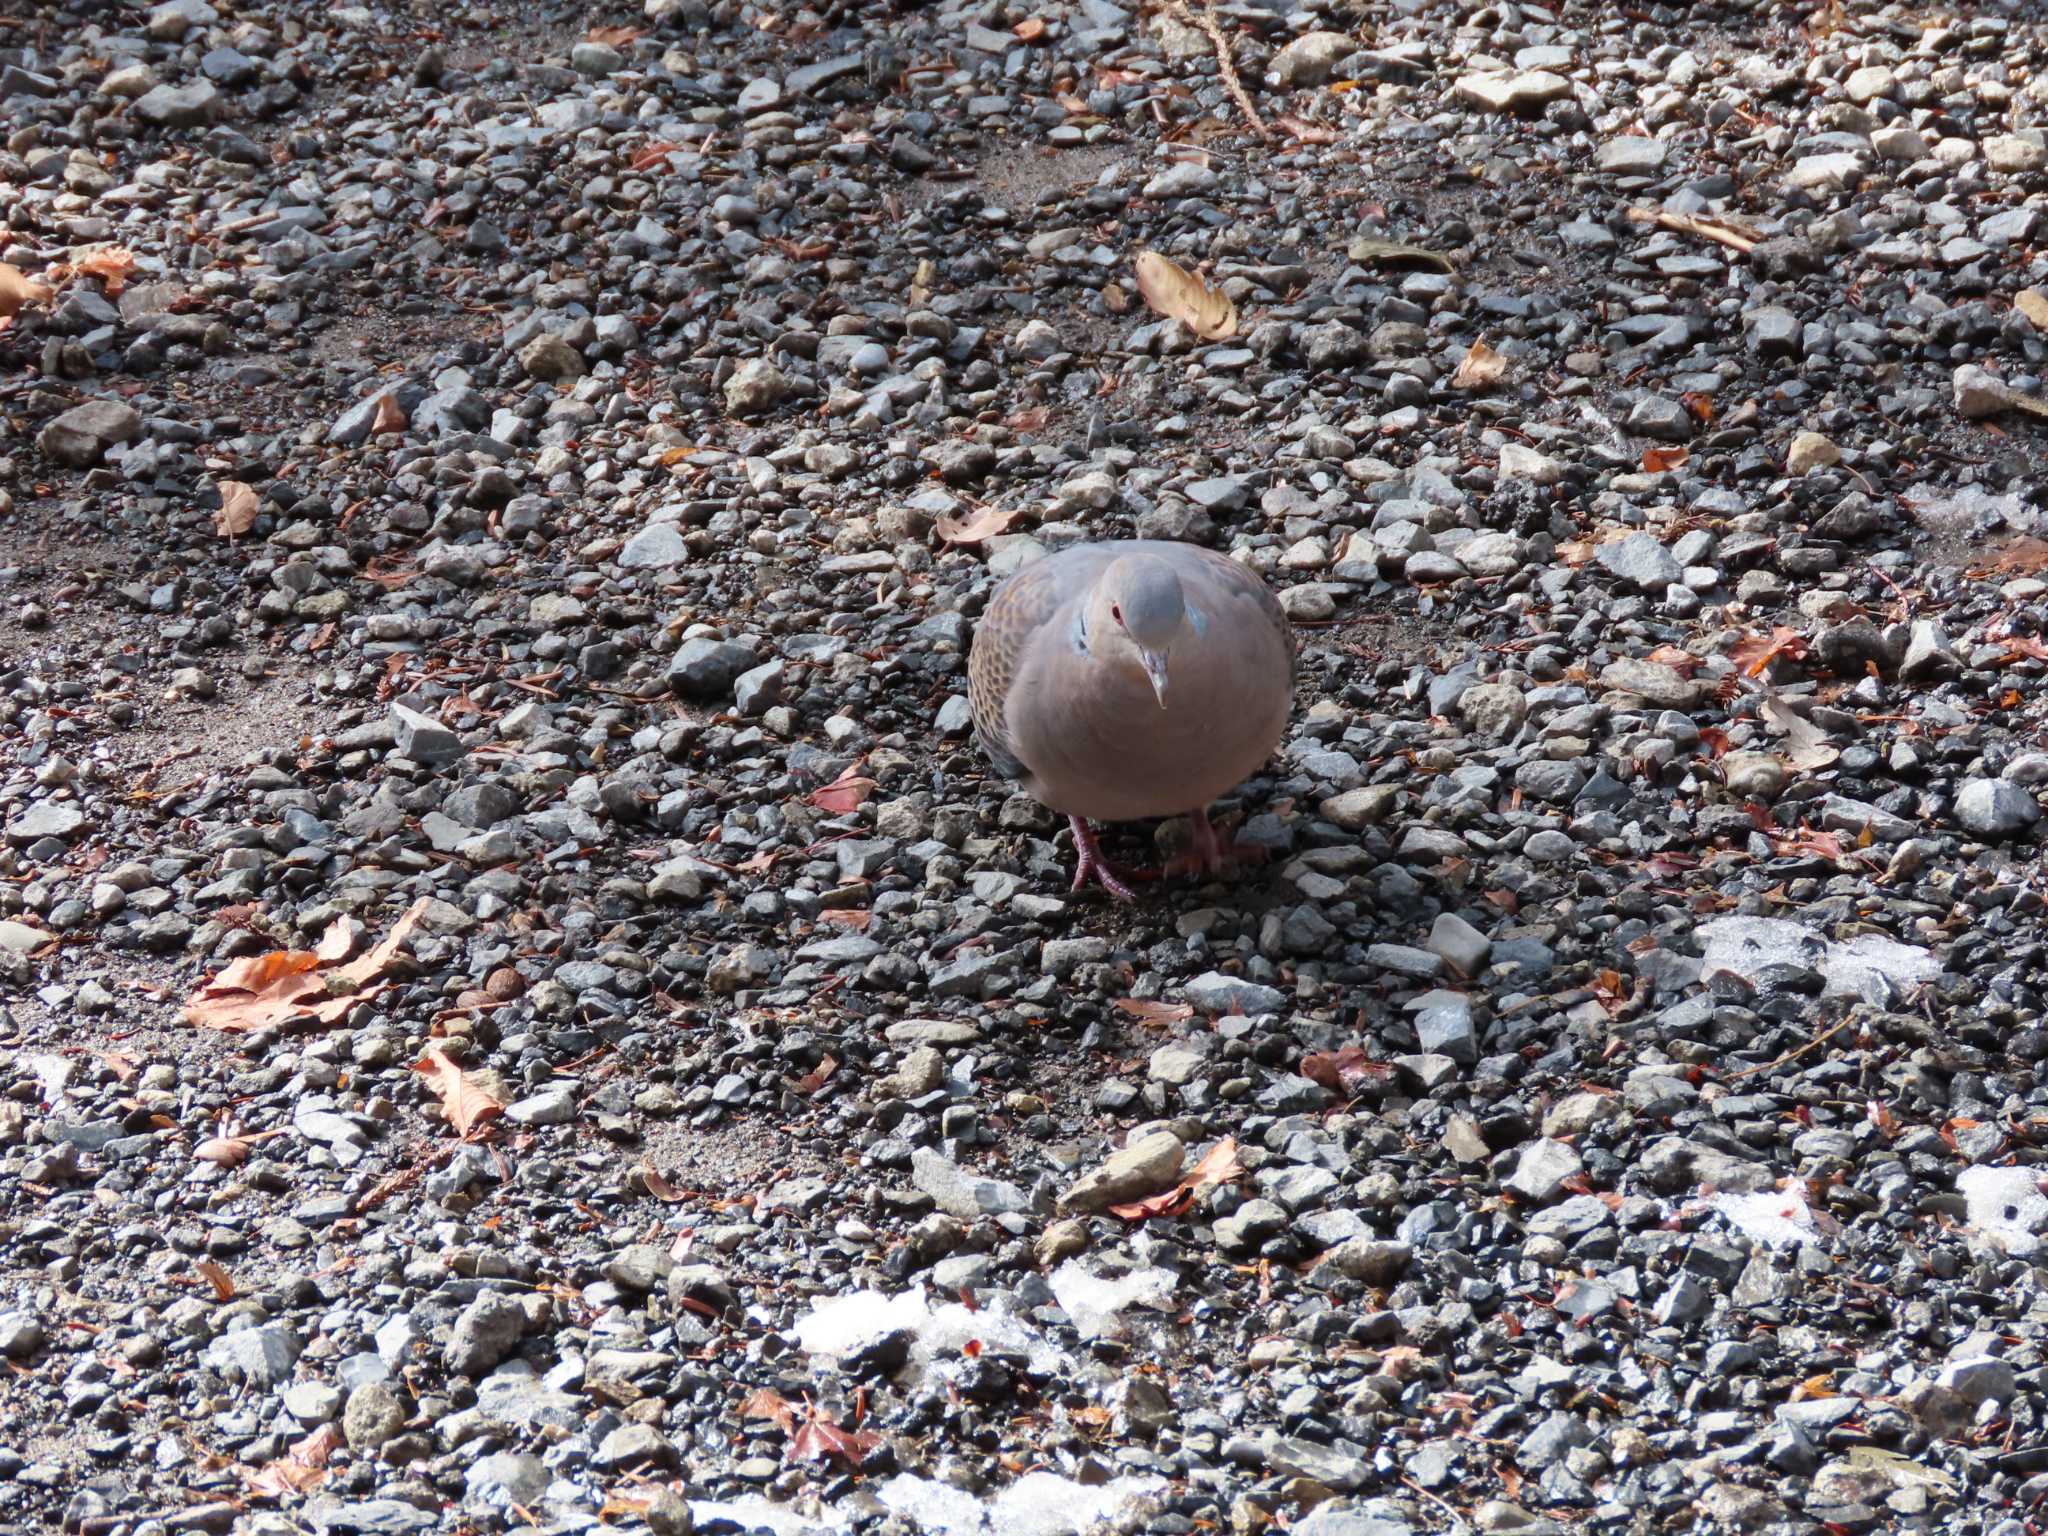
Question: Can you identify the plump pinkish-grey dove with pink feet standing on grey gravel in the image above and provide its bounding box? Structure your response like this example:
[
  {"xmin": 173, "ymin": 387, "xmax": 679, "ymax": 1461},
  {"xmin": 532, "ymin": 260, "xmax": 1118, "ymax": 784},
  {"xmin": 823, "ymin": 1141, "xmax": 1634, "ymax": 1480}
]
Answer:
[{"xmin": 967, "ymin": 539, "xmax": 1294, "ymax": 901}]
